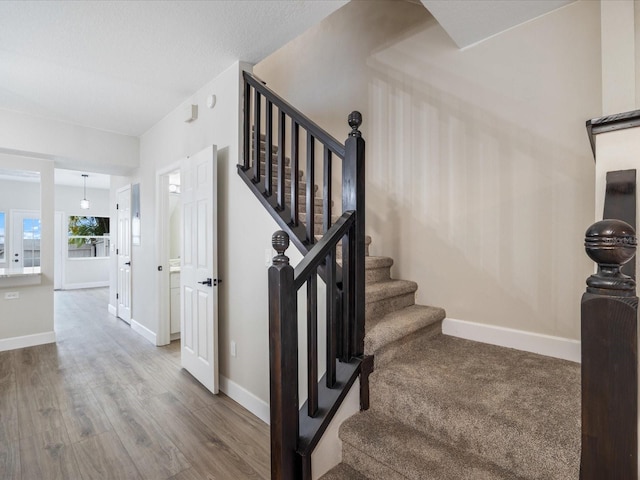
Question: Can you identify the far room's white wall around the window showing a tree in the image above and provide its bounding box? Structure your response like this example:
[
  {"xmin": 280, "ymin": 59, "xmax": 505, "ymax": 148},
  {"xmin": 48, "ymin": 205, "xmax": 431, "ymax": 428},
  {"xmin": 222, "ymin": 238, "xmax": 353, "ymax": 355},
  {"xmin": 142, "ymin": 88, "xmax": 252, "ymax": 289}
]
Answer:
[{"xmin": 55, "ymin": 185, "xmax": 114, "ymax": 289}]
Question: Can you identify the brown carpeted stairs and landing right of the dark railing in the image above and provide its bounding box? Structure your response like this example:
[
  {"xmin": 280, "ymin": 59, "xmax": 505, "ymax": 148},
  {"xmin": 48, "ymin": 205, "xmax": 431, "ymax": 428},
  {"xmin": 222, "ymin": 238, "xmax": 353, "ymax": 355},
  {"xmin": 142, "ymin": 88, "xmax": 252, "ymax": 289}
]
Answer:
[{"xmin": 322, "ymin": 246, "xmax": 580, "ymax": 480}]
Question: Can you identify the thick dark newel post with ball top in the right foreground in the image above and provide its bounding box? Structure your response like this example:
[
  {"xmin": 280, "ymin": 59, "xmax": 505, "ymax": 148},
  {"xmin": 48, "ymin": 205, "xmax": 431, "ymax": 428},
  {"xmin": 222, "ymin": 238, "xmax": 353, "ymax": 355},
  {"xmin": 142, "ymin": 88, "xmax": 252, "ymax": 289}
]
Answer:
[{"xmin": 580, "ymin": 220, "xmax": 638, "ymax": 480}]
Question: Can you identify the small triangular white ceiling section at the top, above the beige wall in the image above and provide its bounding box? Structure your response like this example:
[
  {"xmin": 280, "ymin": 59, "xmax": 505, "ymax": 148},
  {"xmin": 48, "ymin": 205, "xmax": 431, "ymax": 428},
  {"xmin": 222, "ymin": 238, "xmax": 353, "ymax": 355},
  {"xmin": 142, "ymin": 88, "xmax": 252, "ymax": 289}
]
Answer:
[{"xmin": 422, "ymin": 0, "xmax": 575, "ymax": 48}]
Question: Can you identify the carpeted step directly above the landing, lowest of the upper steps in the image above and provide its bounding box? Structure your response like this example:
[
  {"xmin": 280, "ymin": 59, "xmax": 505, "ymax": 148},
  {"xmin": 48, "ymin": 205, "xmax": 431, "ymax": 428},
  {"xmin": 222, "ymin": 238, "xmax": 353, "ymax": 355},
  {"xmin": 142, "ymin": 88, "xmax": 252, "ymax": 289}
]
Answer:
[{"xmin": 364, "ymin": 305, "xmax": 445, "ymax": 355}]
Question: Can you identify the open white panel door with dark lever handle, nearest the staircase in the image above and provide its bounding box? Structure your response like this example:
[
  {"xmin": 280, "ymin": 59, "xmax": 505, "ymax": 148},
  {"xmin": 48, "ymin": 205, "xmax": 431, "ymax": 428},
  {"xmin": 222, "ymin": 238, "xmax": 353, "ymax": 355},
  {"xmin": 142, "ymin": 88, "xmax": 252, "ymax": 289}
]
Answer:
[{"xmin": 180, "ymin": 146, "xmax": 218, "ymax": 393}]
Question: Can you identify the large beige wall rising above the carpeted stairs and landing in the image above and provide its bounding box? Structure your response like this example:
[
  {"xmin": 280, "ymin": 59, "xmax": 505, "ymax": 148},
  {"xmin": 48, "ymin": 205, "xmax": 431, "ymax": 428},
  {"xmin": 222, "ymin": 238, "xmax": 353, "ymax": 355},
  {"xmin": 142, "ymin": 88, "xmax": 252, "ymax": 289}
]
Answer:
[{"xmin": 254, "ymin": 1, "xmax": 602, "ymax": 339}]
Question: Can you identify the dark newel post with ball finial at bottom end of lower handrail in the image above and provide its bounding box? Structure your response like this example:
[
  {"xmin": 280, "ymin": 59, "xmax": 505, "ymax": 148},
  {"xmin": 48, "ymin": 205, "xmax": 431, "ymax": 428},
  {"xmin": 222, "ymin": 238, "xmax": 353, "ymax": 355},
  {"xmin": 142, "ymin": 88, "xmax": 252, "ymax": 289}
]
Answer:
[{"xmin": 269, "ymin": 230, "xmax": 298, "ymax": 480}]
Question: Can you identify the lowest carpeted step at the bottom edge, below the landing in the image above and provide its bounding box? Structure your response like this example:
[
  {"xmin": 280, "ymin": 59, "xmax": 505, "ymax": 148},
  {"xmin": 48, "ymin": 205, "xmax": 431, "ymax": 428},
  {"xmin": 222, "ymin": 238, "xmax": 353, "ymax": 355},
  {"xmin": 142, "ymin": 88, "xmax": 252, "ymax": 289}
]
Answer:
[{"xmin": 340, "ymin": 411, "xmax": 522, "ymax": 480}]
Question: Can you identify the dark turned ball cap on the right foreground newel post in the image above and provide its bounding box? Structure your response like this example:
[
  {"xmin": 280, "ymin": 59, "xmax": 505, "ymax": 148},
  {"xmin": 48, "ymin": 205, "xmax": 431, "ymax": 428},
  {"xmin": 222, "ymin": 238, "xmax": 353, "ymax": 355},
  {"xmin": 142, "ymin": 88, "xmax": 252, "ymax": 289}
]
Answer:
[{"xmin": 584, "ymin": 219, "xmax": 637, "ymax": 297}]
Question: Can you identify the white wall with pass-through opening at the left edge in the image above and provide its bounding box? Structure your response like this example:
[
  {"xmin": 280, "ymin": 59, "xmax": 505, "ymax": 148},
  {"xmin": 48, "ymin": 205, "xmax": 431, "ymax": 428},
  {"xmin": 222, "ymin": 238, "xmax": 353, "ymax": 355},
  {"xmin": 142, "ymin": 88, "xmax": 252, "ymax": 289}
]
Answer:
[{"xmin": 0, "ymin": 154, "xmax": 55, "ymax": 350}]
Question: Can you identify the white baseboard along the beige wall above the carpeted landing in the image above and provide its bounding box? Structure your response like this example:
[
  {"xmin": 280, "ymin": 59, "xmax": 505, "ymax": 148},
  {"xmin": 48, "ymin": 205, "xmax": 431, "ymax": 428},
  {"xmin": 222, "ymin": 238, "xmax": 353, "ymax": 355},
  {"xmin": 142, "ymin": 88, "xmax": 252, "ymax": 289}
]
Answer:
[{"xmin": 442, "ymin": 318, "xmax": 581, "ymax": 363}]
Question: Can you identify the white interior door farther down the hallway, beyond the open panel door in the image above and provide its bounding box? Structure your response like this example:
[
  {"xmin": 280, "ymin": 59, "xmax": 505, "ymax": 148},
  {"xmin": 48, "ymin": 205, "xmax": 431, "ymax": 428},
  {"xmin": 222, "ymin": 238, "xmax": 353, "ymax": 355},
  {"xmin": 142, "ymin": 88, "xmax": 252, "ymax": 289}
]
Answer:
[{"xmin": 116, "ymin": 187, "xmax": 131, "ymax": 324}]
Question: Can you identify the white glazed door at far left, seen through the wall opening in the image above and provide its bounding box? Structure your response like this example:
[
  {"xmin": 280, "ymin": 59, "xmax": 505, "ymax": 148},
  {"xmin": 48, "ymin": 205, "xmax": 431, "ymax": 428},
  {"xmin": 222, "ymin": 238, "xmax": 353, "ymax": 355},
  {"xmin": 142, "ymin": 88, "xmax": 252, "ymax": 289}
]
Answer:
[{"xmin": 7, "ymin": 210, "xmax": 40, "ymax": 268}]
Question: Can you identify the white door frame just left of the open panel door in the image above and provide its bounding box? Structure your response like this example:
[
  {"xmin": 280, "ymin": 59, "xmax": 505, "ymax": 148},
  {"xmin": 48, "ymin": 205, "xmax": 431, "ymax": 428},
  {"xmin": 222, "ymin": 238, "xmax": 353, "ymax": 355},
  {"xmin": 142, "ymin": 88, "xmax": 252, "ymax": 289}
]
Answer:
[{"xmin": 156, "ymin": 159, "xmax": 182, "ymax": 346}]
